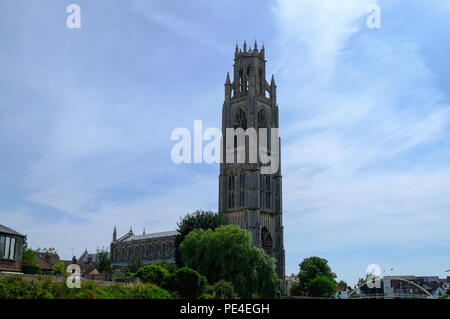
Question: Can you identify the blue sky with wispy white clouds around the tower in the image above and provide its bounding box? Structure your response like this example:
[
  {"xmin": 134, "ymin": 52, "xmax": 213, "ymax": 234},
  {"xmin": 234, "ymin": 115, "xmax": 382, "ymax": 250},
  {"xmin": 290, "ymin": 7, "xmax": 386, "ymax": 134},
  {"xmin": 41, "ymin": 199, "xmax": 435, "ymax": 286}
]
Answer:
[{"xmin": 0, "ymin": 0, "xmax": 450, "ymax": 284}]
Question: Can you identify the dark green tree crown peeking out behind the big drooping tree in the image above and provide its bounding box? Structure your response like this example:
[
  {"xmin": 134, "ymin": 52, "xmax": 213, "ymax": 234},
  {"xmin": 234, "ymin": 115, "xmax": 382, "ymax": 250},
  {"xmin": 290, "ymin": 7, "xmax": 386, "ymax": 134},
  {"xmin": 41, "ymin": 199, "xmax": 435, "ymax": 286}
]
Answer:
[{"xmin": 174, "ymin": 209, "xmax": 229, "ymax": 267}]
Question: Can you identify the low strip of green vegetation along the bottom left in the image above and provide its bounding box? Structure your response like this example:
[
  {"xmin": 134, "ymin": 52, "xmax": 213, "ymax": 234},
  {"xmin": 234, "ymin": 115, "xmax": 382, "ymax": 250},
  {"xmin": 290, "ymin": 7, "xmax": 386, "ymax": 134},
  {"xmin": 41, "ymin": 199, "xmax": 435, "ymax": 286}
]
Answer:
[{"xmin": 0, "ymin": 276, "xmax": 172, "ymax": 299}]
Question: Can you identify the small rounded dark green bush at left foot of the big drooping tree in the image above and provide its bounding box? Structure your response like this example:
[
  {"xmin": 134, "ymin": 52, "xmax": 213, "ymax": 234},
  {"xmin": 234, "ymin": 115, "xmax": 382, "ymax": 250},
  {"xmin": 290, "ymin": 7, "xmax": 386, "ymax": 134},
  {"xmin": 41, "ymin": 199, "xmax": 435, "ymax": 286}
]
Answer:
[{"xmin": 163, "ymin": 267, "xmax": 207, "ymax": 299}]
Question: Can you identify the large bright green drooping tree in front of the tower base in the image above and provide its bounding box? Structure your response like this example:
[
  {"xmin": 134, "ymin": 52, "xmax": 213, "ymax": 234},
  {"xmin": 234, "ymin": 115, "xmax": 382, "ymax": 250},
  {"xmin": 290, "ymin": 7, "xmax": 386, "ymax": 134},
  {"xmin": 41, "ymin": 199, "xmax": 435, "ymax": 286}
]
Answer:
[{"xmin": 180, "ymin": 225, "xmax": 279, "ymax": 298}]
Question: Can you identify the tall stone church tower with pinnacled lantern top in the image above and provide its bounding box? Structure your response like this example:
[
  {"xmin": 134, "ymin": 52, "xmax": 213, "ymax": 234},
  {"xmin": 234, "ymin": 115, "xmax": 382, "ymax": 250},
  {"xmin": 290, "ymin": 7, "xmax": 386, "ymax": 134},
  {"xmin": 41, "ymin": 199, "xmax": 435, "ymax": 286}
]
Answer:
[{"xmin": 219, "ymin": 41, "xmax": 285, "ymax": 280}]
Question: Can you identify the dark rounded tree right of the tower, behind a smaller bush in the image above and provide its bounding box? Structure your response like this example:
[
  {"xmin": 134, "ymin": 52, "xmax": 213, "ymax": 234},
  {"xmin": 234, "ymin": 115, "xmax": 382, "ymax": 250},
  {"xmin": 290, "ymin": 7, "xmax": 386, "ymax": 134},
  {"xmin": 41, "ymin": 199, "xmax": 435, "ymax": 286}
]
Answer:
[{"xmin": 297, "ymin": 256, "xmax": 336, "ymax": 294}]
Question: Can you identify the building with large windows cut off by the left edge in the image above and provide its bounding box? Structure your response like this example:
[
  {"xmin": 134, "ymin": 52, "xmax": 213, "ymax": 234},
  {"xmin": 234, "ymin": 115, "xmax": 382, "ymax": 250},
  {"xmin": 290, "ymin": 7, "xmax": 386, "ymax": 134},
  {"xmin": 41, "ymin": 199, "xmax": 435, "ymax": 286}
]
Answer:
[{"xmin": 0, "ymin": 225, "xmax": 25, "ymax": 272}]
